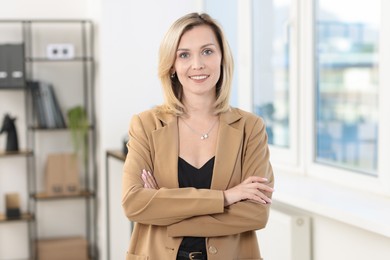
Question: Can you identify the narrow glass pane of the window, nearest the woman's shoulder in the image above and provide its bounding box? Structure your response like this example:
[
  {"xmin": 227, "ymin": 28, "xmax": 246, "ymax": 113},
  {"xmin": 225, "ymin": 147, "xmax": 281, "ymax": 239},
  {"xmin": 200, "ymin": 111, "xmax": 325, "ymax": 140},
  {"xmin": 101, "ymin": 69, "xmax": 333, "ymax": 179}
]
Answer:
[{"xmin": 253, "ymin": 0, "xmax": 291, "ymax": 148}]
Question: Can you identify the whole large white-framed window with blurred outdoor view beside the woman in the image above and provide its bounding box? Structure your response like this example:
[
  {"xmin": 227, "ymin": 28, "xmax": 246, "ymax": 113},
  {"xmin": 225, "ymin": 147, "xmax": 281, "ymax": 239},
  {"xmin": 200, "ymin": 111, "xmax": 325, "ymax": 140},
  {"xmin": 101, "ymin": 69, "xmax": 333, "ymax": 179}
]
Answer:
[{"xmin": 248, "ymin": 0, "xmax": 390, "ymax": 193}]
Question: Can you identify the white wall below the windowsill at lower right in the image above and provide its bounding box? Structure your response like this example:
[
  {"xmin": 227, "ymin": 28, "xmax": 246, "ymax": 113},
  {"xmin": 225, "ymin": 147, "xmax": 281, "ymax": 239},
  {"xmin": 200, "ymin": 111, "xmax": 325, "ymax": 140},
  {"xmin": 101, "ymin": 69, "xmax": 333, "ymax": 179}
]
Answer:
[{"xmin": 258, "ymin": 204, "xmax": 390, "ymax": 260}]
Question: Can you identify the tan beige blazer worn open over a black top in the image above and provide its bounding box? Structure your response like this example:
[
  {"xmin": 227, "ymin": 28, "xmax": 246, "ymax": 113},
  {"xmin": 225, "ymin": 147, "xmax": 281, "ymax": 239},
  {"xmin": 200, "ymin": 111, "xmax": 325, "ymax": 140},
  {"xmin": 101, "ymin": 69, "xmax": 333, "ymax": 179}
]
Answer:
[{"xmin": 122, "ymin": 106, "xmax": 274, "ymax": 260}]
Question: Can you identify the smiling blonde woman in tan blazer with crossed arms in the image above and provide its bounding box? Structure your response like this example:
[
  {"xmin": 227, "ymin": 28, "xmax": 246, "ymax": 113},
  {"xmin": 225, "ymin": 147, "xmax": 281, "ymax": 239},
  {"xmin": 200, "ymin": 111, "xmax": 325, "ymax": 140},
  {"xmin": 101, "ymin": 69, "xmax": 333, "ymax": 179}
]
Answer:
[{"xmin": 122, "ymin": 13, "xmax": 273, "ymax": 260}]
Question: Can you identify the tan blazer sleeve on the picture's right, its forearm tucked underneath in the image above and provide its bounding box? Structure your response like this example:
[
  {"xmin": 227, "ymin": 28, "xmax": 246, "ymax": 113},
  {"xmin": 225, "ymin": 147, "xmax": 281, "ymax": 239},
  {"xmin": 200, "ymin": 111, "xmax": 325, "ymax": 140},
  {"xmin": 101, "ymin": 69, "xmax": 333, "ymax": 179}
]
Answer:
[{"xmin": 168, "ymin": 119, "xmax": 274, "ymax": 237}]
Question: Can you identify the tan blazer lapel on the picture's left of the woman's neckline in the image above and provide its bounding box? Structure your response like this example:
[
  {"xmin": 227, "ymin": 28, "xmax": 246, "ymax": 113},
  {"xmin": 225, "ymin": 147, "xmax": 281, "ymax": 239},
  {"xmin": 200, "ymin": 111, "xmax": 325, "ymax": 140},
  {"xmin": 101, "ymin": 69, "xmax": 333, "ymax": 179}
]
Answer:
[{"xmin": 152, "ymin": 114, "xmax": 179, "ymax": 188}]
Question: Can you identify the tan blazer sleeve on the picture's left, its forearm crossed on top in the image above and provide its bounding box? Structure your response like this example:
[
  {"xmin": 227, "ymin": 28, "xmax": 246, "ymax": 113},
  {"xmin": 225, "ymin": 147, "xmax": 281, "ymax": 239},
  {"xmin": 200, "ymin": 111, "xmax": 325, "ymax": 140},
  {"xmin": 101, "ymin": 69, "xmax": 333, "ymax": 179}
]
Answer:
[{"xmin": 122, "ymin": 116, "xmax": 224, "ymax": 226}]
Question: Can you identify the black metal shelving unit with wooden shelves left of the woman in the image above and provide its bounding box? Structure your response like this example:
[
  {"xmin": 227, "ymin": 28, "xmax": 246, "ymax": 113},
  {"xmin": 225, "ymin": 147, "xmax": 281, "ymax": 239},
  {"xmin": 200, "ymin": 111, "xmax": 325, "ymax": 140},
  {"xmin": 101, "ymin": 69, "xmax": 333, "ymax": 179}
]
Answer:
[{"xmin": 0, "ymin": 20, "xmax": 98, "ymax": 260}]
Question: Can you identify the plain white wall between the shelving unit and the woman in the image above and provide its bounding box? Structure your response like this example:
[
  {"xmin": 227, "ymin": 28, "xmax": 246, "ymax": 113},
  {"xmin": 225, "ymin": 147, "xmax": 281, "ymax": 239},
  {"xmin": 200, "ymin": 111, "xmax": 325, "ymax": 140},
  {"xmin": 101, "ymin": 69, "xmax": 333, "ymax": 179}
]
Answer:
[{"xmin": 97, "ymin": 0, "xmax": 202, "ymax": 259}]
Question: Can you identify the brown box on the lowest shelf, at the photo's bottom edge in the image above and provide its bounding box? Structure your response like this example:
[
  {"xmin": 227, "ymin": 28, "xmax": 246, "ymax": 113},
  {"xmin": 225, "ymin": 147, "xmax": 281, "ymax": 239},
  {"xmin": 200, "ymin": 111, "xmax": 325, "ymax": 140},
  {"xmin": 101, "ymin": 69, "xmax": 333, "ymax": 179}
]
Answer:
[{"xmin": 37, "ymin": 237, "xmax": 89, "ymax": 260}]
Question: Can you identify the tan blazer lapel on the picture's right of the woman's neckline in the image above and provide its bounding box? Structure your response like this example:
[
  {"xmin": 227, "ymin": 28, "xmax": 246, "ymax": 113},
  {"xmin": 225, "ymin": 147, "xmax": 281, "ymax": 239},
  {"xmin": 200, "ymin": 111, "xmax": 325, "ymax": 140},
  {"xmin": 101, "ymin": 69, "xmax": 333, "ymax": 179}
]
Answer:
[{"xmin": 211, "ymin": 108, "xmax": 243, "ymax": 190}]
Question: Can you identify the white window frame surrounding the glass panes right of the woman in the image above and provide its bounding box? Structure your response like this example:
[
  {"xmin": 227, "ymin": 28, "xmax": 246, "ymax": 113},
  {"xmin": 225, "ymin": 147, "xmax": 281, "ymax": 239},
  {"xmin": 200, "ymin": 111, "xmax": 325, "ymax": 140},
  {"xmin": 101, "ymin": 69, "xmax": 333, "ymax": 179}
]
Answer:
[{"xmin": 236, "ymin": 0, "xmax": 390, "ymax": 195}]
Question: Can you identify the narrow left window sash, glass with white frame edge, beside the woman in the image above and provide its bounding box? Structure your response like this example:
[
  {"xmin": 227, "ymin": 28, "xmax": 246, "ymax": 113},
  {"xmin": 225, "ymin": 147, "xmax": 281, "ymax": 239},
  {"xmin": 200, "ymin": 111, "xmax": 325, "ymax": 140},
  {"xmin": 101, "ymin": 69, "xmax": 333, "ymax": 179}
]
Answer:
[{"xmin": 251, "ymin": 0, "xmax": 298, "ymax": 166}]
